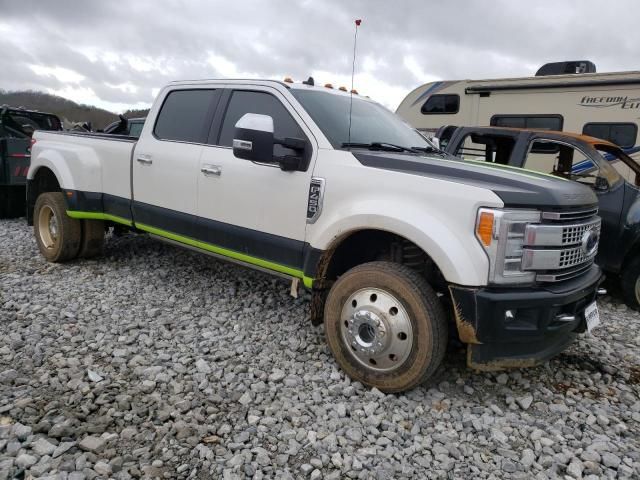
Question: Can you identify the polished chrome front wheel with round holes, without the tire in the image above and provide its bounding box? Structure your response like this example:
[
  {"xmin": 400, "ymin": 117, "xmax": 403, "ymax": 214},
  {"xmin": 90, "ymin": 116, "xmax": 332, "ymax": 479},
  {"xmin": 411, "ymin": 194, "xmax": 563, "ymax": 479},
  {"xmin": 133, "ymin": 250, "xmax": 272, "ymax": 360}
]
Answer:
[{"xmin": 340, "ymin": 288, "xmax": 413, "ymax": 371}]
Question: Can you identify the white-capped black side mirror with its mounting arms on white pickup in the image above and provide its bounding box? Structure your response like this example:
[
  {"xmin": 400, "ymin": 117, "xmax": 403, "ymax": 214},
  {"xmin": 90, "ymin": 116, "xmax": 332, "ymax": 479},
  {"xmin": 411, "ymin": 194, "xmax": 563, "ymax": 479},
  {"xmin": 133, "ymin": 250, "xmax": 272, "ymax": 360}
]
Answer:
[{"xmin": 233, "ymin": 113, "xmax": 306, "ymax": 171}]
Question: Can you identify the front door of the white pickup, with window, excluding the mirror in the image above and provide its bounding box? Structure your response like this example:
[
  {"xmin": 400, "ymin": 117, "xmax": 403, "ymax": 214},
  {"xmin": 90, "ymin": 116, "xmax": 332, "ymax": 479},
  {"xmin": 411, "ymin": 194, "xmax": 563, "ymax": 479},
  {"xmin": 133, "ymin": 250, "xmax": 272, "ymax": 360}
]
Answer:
[{"xmin": 197, "ymin": 86, "xmax": 317, "ymax": 276}]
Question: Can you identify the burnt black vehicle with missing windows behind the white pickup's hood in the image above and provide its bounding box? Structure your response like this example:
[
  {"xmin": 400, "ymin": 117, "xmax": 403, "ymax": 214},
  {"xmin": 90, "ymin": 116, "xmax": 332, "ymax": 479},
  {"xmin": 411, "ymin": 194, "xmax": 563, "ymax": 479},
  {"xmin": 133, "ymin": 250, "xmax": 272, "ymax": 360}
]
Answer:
[{"xmin": 446, "ymin": 127, "xmax": 640, "ymax": 309}]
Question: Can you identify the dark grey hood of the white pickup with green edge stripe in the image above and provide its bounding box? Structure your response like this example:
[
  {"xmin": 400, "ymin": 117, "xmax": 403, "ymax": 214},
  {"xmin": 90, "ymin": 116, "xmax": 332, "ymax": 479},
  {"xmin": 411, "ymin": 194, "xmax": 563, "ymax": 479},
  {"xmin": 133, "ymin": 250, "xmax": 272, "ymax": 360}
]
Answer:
[{"xmin": 351, "ymin": 151, "xmax": 598, "ymax": 209}]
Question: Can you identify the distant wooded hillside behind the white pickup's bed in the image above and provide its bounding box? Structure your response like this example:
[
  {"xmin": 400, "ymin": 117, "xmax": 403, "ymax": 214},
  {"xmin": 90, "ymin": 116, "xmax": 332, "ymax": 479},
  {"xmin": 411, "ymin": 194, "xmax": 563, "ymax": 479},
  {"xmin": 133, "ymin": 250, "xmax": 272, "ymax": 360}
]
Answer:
[{"xmin": 0, "ymin": 89, "xmax": 149, "ymax": 129}]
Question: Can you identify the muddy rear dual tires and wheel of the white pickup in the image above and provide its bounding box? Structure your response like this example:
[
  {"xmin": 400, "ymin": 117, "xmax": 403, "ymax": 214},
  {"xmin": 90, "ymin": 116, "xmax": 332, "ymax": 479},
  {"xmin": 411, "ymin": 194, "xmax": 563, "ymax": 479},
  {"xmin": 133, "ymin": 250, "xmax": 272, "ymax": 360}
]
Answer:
[{"xmin": 33, "ymin": 192, "xmax": 82, "ymax": 262}]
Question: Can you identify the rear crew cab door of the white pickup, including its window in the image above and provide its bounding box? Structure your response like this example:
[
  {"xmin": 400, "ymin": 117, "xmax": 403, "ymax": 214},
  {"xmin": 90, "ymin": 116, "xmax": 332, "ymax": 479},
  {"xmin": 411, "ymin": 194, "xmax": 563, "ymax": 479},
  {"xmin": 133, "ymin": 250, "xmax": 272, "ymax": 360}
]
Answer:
[{"xmin": 132, "ymin": 87, "xmax": 219, "ymax": 231}]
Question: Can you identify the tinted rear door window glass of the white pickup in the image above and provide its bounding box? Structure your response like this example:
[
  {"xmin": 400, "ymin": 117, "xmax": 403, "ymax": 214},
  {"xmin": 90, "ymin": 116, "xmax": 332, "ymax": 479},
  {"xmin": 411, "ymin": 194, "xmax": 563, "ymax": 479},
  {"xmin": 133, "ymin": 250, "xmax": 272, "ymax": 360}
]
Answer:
[{"xmin": 153, "ymin": 90, "xmax": 215, "ymax": 143}]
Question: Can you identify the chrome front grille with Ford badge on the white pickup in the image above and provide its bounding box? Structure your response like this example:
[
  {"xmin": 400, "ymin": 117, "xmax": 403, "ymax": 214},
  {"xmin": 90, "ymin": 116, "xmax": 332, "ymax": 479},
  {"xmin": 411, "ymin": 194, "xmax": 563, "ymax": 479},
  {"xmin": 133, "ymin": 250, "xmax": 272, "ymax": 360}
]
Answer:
[{"xmin": 522, "ymin": 209, "xmax": 600, "ymax": 282}]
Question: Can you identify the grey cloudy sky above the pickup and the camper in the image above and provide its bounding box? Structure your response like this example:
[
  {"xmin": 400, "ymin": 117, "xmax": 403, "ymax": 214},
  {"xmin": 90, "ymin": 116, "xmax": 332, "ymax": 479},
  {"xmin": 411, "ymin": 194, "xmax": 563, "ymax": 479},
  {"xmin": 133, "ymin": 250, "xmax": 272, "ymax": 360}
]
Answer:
[{"xmin": 0, "ymin": 0, "xmax": 640, "ymax": 112}]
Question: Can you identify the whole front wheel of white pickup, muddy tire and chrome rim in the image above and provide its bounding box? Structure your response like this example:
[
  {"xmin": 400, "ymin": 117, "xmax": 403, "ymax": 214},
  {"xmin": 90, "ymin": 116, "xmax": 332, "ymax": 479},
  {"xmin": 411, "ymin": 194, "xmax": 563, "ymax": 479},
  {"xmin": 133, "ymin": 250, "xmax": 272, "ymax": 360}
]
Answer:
[{"xmin": 324, "ymin": 262, "xmax": 448, "ymax": 393}]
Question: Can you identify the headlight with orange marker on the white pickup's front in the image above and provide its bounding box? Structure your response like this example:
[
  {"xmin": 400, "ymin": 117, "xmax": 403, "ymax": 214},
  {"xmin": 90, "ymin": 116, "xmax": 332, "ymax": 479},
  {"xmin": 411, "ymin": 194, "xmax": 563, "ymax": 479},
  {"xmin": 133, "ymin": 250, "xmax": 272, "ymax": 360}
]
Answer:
[{"xmin": 476, "ymin": 208, "xmax": 540, "ymax": 285}]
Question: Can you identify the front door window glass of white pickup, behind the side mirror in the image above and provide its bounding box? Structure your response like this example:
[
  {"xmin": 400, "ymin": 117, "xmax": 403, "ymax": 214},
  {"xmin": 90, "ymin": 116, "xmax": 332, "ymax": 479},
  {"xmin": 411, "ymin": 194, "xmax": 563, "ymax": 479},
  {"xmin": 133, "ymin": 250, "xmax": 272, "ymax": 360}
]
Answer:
[{"xmin": 217, "ymin": 90, "xmax": 306, "ymax": 155}]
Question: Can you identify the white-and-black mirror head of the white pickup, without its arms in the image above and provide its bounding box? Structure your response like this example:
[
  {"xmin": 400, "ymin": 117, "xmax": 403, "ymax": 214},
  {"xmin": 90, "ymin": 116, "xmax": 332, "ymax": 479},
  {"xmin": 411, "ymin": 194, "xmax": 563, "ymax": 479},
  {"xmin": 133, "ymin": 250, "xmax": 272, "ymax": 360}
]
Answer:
[{"xmin": 233, "ymin": 113, "xmax": 275, "ymax": 163}]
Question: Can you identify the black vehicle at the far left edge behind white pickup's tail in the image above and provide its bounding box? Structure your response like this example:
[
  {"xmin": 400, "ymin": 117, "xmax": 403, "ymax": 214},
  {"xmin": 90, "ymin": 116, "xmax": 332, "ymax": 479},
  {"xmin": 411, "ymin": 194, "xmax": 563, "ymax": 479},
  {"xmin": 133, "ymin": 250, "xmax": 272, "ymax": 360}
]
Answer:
[{"xmin": 0, "ymin": 106, "xmax": 62, "ymax": 218}]
